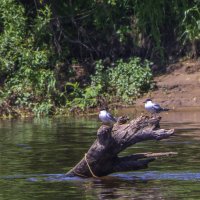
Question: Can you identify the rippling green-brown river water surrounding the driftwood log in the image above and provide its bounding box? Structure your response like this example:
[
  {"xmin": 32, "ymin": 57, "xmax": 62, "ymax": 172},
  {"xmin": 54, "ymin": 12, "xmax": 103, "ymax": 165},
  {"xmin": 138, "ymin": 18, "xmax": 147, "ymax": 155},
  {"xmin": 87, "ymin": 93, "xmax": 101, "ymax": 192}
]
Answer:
[{"xmin": 0, "ymin": 108, "xmax": 200, "ymax": 200}]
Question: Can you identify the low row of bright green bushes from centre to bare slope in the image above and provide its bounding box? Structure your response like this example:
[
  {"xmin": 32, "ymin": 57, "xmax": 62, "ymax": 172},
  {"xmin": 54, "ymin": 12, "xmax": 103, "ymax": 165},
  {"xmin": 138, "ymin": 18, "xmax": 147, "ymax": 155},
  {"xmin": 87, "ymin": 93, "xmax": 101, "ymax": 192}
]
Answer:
[{"xmin": 67, "ymin": 57, "xmax": 152, "ymax": 110}]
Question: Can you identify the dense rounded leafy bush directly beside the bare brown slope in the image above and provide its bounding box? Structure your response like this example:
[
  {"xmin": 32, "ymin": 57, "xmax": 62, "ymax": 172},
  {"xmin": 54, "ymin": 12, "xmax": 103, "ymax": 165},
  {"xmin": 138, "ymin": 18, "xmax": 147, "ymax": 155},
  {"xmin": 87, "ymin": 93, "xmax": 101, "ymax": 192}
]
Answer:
[{"xmin": 109, "ymin": 57, "xmax": 152, "ymax": 102}]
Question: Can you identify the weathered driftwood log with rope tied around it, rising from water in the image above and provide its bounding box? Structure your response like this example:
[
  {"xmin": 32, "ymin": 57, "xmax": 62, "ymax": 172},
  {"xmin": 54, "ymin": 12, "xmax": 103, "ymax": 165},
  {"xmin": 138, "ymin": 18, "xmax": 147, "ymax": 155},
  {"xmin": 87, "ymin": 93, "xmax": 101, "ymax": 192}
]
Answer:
[{"xmin": 66, "ymin": 116, "xmax": 175, "ymax": 177}]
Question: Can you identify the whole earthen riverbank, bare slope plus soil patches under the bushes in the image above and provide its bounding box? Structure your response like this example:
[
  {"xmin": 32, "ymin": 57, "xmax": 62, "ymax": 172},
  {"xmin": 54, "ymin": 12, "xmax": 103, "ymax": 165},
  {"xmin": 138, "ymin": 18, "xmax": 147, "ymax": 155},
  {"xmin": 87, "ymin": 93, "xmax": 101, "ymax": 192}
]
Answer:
[{"xmin": 1, "ymin": 60, "xmax": 200, "ymax": 118}]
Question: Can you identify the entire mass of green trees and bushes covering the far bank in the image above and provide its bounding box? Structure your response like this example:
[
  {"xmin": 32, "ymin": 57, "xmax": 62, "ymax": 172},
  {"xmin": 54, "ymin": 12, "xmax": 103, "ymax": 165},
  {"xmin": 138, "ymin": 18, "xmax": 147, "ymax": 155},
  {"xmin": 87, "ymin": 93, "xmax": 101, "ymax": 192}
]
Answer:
[{"xmin": 0, "ymin": 0, "xmax": 200, "ymax": 116}]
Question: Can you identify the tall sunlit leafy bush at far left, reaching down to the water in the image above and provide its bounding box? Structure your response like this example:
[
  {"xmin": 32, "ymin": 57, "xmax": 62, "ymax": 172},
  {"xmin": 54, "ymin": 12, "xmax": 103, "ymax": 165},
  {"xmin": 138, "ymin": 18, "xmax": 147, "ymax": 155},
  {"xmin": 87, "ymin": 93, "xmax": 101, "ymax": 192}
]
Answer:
[{"xmin": 0, "ymin": 0, "xmax": 56, "ymax": 114}]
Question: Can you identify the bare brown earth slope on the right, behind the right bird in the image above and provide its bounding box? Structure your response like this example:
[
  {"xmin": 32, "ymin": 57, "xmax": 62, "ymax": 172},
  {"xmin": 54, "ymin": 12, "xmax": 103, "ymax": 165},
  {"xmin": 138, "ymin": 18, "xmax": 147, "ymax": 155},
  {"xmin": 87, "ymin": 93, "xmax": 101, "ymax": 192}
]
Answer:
[{"xmin": 136, "ymin": 60, "xmax": 200, "ymax": 108}]
